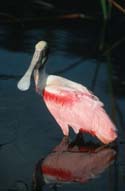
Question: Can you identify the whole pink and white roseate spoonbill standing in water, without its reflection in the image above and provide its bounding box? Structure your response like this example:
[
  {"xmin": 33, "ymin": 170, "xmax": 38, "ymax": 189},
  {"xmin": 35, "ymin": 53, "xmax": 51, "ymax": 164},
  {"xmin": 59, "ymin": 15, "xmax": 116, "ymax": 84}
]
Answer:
[{"xmin": 18, "ymin": 41, "xmax": 117, "ymax": 144}]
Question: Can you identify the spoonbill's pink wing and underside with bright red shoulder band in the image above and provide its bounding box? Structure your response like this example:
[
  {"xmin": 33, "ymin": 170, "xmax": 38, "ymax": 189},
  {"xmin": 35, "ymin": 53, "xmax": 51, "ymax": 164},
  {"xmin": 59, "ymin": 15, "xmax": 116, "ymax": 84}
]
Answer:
[{"xmin": 43, "ymin": 85, "xmax": 117, "ymax": 143}]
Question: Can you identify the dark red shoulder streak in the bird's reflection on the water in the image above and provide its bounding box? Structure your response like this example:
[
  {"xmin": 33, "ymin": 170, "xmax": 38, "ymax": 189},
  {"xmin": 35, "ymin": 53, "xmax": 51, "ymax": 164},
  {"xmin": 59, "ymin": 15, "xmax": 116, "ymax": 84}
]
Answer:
[{"xmin": 41, "ymin": 165, "xmax": 72, "ymax": 180}]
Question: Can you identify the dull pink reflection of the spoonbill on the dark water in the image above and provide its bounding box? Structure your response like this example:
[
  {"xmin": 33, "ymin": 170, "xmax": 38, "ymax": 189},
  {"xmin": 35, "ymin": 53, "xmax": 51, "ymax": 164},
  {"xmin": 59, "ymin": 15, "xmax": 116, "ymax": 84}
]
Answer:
[{"xmin": 33, "ymin": 135, "xmax": 116, "ymax": 191}]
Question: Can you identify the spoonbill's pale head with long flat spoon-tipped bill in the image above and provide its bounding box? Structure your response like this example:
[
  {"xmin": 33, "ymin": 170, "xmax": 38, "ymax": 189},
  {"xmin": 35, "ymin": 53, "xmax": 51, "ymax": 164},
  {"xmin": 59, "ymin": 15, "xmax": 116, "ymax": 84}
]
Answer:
[{"xmin": 17, "ymin": 41, "xmax": 48, "ymax": 91}]
